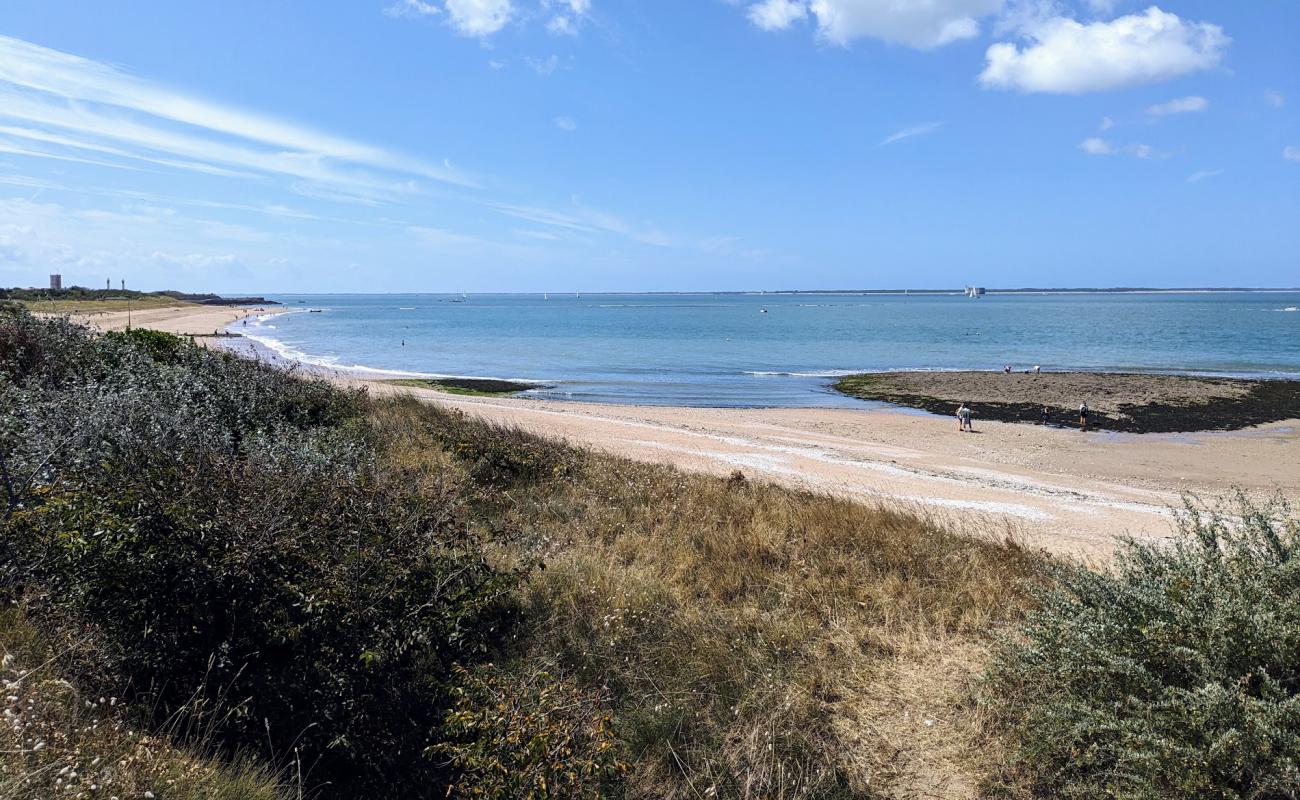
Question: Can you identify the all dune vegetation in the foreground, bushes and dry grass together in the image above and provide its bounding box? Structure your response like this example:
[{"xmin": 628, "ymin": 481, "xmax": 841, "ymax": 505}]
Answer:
[{"xmin": 0, "ymin": 307, "xmax": 1300, "ymax": 800}]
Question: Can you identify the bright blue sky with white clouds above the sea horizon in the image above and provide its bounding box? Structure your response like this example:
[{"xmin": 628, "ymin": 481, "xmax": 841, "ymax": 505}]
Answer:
[{"xmin": 0, "ymin": 0, "xmax": 1300, "ymax": 293}]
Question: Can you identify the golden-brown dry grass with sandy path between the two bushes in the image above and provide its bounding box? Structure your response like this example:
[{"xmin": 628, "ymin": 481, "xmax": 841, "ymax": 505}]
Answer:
[{"xmin": 376, "ymin": 399, "xmax": 1039, "ymax": 799}]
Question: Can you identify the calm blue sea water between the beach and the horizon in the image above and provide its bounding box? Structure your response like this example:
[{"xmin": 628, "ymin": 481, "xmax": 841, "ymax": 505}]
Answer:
[{"xmin": 233, "ymin": 293, "xmax": 1300, "ymax": 406}]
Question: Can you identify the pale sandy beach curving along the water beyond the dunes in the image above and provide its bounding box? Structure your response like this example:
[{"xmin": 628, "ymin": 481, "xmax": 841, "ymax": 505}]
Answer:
[{"xmin": 82, "ymin": 306, "xmax": 1300, "ymax": 557}]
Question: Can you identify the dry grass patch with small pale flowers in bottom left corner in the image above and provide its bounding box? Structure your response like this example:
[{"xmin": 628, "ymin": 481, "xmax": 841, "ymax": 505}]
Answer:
[{"xmin": 0, "ymin": 609, "xmax": 293, "ymax": 800}]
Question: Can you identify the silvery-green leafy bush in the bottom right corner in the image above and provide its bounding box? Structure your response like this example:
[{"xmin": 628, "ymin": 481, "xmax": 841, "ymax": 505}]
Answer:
[{"xmin": 991, "ymin": 498, "xmax": 1300, "ymax": 799}]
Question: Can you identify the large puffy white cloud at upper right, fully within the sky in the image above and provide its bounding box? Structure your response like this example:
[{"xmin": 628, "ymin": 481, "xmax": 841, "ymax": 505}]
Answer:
[{"xmin": 980, "ymin": 7, "xmax": 1231, "ymax": 94}]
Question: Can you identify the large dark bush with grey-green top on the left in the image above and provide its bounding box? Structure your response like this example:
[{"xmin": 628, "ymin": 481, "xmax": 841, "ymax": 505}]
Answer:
[{"xmin": 0, "ymin": 311, "xmax": 515, "ymax": 796}]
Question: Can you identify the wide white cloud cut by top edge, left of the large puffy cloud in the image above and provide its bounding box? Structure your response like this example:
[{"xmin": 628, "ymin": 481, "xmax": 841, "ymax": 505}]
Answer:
[{"xmin": 746, "ymin": 0, "xmax": 1002, "ymax": 49}]
